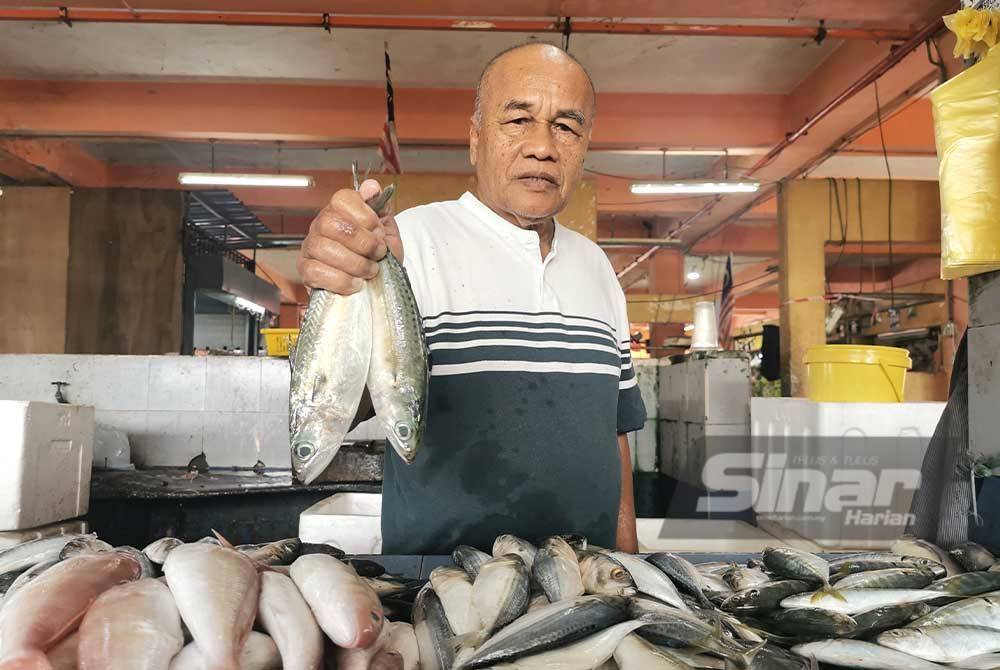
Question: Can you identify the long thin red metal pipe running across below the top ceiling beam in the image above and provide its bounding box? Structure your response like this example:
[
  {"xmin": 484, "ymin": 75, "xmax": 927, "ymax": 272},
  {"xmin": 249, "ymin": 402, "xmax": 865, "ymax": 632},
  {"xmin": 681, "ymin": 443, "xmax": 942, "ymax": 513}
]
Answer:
[{"xmin": 0, "ymin": 7, "xmax": 913, "ymax": 42}]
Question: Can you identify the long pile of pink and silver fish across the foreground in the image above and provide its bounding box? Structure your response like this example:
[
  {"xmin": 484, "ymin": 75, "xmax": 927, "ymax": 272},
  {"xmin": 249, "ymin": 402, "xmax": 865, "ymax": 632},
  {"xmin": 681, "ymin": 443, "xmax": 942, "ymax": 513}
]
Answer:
[{"xmin": 9, "ymin": 535, "xmax": 1000, "ymax": 670}]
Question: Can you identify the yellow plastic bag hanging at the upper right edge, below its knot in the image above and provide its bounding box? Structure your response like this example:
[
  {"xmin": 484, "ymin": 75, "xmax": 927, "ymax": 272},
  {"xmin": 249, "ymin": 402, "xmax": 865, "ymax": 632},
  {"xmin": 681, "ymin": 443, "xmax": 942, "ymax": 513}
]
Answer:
[{"xmin": 931, "ymin": 46, "xmax": 1000, "ymax": 279}]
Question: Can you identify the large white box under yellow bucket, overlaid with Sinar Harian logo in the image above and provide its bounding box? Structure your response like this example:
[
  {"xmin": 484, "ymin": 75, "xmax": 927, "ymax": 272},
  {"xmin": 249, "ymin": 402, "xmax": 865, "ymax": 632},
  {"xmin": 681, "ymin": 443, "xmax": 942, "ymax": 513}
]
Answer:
[{"xmin": 751, "ymin": 398, "xmax": 945, "ymax": 549}]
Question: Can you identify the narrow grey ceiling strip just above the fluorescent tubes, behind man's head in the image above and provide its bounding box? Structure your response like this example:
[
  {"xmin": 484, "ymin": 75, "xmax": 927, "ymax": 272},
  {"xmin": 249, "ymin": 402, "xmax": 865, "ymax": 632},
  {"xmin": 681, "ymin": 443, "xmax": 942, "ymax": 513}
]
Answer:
[{"xmin": 80, "ymin": 141, "xmax": 722, "ymax": 179}]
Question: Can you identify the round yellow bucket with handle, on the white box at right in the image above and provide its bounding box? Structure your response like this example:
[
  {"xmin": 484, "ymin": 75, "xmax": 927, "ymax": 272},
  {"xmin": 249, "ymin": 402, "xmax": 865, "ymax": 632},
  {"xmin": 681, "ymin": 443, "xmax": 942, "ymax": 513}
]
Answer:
[{"xmin": 805, "ymin": 344, "xmax": 913, "ymax": 402}]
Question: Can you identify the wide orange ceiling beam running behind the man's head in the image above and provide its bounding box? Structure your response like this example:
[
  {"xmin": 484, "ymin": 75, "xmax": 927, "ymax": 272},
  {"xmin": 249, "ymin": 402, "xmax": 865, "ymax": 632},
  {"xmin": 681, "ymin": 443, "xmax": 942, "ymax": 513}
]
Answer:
[{"xmin": 0, "ymin": 80, "xmax": 784, "ymax": 149}]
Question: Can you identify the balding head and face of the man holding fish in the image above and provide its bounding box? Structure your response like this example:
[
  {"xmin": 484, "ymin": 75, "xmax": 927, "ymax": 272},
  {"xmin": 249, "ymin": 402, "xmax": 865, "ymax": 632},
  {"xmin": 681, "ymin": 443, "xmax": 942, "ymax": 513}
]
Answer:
[{"xmin": 469, "ymin": 45, "xmax": 594, "ymax": 226}]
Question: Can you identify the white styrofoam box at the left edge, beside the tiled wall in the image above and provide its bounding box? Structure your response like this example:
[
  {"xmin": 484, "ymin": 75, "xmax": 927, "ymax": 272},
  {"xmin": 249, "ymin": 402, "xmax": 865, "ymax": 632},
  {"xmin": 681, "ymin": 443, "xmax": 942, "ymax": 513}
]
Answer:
[{"xmin": 0, "ymin": 400, "xmax": 94, "ymax": 530}]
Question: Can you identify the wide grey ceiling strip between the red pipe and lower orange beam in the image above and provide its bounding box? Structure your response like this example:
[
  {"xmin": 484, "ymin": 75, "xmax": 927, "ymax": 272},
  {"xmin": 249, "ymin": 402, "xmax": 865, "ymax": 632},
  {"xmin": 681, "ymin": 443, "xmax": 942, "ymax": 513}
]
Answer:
[{"xmin": 0, "ymin": 22, "xmax": 840, "ymax": 95}]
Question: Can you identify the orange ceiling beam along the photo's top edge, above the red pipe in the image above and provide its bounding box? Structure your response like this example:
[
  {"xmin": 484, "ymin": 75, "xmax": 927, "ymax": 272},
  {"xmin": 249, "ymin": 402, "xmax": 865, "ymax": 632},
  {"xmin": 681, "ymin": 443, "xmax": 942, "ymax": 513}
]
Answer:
[{"xmin": 4, "ymin": 0, "xmax": 956, "ymax": 28}]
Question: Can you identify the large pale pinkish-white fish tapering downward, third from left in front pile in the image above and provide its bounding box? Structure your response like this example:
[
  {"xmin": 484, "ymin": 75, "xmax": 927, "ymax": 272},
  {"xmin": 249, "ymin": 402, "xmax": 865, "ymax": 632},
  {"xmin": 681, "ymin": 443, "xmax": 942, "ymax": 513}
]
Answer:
[{"xmin": 163, "ymin": 543, "xmax": 260, "ymax": 670}]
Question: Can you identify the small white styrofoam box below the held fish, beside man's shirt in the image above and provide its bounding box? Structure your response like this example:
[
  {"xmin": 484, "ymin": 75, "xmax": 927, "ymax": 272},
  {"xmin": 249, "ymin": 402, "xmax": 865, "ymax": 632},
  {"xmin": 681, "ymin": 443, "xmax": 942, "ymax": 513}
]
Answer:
[{"xmin": 299, "ymin": 493, "xmax": 382, "ymax": 554}]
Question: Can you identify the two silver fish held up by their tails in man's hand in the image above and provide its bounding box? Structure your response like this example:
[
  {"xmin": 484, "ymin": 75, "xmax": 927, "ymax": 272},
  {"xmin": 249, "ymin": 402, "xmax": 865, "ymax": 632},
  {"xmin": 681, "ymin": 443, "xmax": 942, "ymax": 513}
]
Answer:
[{"xmin": 289, "ymin": 177, "xmax": 428, "ymax": 484}]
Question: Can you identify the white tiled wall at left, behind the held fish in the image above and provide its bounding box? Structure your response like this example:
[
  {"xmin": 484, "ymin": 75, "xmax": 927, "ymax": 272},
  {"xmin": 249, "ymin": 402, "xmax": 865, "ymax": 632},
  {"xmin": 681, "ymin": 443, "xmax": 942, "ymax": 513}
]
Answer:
[{"xmin": 0, "ymin": 355, "xmax": 378, "ymax": 468}]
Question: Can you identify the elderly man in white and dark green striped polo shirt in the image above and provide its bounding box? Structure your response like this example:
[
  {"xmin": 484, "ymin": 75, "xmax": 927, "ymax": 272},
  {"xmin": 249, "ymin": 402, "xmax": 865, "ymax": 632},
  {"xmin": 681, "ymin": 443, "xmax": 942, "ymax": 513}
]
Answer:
[{"xmin": 299, "ymin": 44, "xmax": 645, "ymax": 554}]
